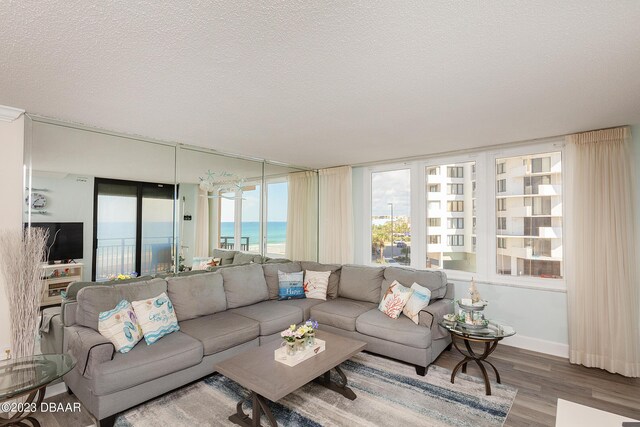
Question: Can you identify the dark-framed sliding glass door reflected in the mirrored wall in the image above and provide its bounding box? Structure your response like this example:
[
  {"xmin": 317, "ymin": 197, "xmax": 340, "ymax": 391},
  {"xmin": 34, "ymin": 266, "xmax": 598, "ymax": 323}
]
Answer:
[{"xmin": 92, "ymin": 178, "xmax": 174, "ymax": 281}]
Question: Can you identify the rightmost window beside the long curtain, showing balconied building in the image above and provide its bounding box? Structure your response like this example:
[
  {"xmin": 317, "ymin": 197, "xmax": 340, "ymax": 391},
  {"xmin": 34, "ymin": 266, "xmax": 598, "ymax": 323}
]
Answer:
[{"xmin": 496, "ymin": 152, "xmax": 563, "ymax": 278}]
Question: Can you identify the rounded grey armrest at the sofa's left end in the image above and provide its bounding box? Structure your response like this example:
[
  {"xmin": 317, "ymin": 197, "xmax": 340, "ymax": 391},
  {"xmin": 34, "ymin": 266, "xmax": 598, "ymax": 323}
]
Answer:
[{"xmin": 65, "ymin": 326, "xmax": 115, "ymax": 378}]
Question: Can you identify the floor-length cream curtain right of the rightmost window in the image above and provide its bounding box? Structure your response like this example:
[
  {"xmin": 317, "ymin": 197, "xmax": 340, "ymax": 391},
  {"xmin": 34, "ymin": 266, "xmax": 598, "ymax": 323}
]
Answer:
[{"xmin": 565, "ymin": 127, "xmax": 640, "ymax": 377}]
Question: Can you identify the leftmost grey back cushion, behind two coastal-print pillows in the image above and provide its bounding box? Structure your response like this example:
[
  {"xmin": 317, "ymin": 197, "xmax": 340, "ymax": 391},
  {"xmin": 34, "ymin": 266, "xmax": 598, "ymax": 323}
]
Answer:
[{"xmin": 76, "ymin": 279, "xmax": 167, "ymax": 331}]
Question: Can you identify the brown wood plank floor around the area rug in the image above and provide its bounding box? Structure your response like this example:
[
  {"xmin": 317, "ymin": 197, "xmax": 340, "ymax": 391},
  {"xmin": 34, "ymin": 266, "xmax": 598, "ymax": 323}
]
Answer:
[{"xmin": 27, "ymin": 345, "xmax": 640, "ymax": 427}]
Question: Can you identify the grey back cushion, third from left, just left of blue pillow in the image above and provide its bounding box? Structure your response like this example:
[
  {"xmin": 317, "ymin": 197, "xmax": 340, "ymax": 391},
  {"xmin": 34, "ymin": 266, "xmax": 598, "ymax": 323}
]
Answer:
[{"xmin": 220, "ymin": 264, "xmax": 269, "ymax": 308}]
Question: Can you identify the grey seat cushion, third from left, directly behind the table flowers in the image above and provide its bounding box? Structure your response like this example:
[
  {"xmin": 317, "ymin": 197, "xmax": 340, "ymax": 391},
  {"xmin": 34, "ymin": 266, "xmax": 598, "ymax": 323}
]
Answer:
[{"xmin": 231, "ymin": 301, "xmax": 302, "ymax": 336}]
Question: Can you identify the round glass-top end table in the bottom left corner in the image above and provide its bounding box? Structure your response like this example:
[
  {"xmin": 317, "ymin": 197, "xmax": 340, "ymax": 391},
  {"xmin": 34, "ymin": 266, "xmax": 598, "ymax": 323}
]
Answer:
[{"xmin": 0, "ymin": 354, "xmax": 76, "ymax": 427}]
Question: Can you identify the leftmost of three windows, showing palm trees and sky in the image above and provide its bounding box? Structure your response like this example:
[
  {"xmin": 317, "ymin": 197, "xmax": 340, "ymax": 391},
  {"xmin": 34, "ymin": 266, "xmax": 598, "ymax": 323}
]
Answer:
[{"xmin": 371, "ymin": 169, "xmax": 411, "ymax": 265}]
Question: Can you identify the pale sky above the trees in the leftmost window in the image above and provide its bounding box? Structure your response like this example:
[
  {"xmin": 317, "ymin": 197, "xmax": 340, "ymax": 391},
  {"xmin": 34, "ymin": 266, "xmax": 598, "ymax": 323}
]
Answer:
[{"xmin": 371, "ymin": 169, "xmax": 411, "ymax": 216}]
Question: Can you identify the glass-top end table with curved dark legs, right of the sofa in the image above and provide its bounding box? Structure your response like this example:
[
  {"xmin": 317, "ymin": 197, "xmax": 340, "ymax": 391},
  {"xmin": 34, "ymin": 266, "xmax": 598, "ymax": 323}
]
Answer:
[{"xmin": 439, "ymin": 320, "xmax": 516, "ymax": 396}]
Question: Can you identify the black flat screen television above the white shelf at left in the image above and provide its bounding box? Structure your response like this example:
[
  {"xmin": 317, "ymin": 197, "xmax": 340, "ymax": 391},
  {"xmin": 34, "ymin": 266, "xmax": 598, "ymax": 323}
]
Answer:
[{"xmin": 31, "ymin": 222, "xmax": 84, "ymax": 262}]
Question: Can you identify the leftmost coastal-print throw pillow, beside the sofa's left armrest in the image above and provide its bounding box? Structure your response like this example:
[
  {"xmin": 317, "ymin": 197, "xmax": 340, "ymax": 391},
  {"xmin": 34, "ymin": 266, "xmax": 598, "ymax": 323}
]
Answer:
[{"xmin": 98, "ymin": 299, "xmax": 142, "ymax": 353}]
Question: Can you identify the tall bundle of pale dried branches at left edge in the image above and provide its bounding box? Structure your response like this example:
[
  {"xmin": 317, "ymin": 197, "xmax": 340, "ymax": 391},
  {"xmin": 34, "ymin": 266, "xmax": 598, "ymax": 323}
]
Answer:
[{"xmin": 0, "ymin": 228, "xmax": 48, "ymax": 357}]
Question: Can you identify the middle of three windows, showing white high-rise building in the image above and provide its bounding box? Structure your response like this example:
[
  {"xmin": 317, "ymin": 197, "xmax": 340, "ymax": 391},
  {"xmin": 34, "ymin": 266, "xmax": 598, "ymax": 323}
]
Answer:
[{"xmin": 425, "ymin": 162, "xmax": 477, "ymax": 272}]
